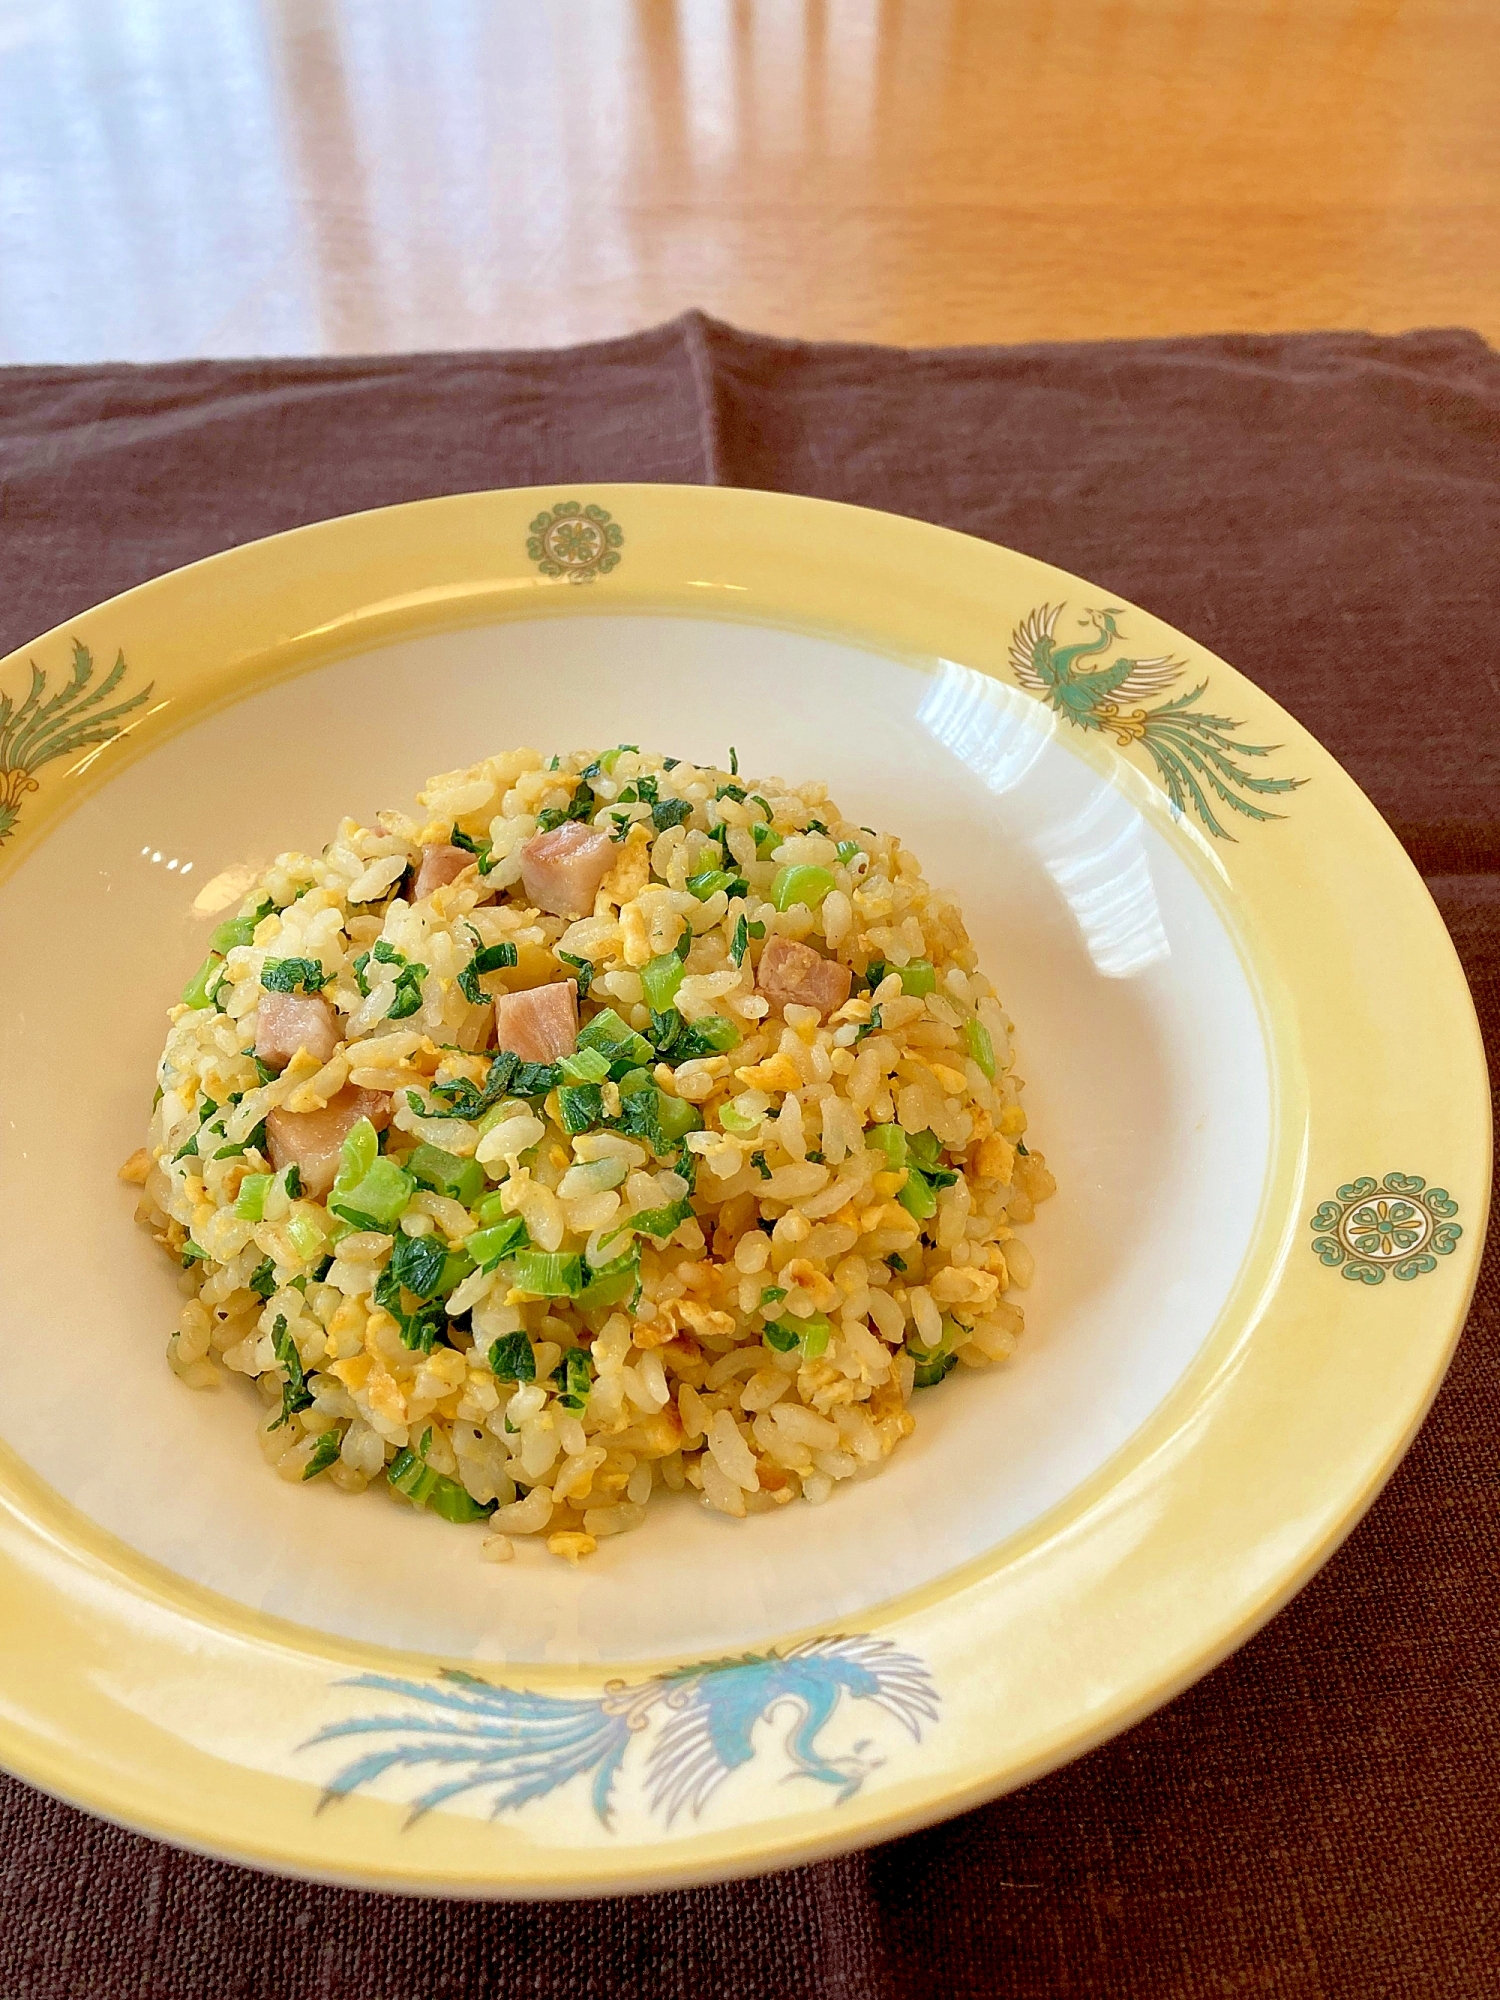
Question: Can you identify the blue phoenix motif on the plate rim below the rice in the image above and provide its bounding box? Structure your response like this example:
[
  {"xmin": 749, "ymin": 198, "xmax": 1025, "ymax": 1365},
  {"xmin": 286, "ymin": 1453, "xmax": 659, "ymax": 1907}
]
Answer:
[{"xmin": 302, "ymin": 1634, "xmax": 938, "ymax": 1828}]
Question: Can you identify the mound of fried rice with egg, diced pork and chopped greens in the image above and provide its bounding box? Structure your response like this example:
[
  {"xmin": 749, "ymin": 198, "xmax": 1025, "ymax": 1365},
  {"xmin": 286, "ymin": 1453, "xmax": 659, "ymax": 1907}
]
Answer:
[{"xmin": 122, "ymin": 746, "xmax": 1054, "ymax": 1560}]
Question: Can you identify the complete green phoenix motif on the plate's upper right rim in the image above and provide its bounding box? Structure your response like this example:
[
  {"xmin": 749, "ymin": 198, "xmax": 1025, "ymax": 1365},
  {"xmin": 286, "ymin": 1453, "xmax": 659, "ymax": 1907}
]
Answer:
[{"xmin": 1010, "ymin": 604, "xmax": 1306, "ymax": 840}]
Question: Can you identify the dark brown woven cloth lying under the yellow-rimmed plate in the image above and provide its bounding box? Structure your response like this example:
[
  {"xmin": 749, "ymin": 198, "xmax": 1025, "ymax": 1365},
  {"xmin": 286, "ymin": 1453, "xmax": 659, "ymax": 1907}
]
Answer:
[{"xmin": 0, "ymin": 314, "xmax": 1500, "ymax": 2000}]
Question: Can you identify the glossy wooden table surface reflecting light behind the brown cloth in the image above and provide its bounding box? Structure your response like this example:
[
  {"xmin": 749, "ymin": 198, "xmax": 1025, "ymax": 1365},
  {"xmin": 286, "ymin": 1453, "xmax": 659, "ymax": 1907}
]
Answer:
[{"xmin": 0, "ymin": 0, "xmax": 1500, "ymax": 360}]
